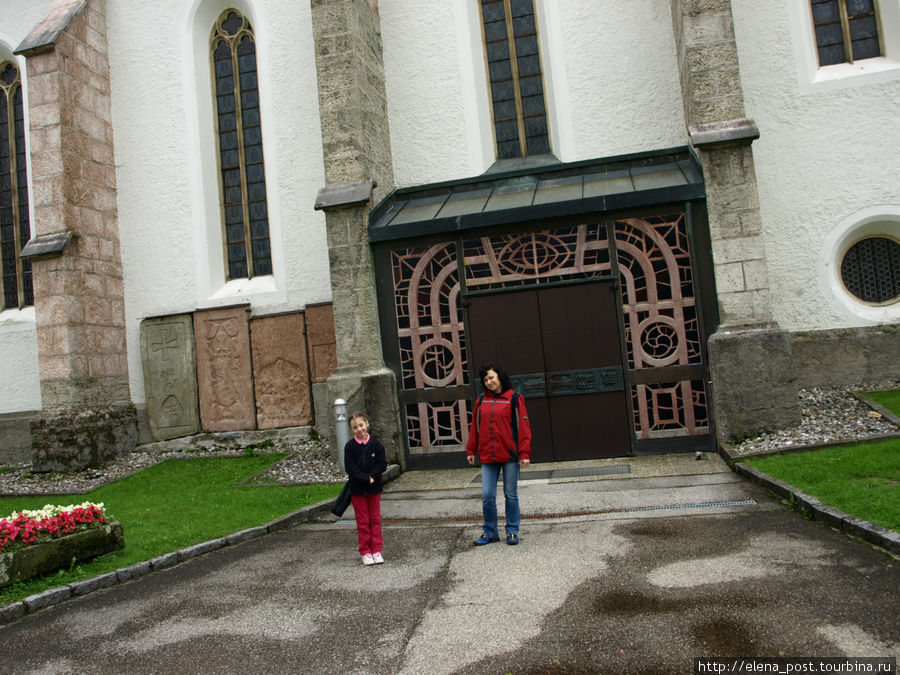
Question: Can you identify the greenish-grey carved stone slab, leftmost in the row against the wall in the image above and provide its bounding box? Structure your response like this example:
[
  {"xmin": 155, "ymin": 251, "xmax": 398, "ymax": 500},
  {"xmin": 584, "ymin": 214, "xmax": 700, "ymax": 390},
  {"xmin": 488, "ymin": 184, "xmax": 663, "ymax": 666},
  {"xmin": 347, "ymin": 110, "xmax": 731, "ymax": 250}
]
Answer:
[{"xmin": 141, "ymin": 314, "xmax": 200, "ymax": 441}]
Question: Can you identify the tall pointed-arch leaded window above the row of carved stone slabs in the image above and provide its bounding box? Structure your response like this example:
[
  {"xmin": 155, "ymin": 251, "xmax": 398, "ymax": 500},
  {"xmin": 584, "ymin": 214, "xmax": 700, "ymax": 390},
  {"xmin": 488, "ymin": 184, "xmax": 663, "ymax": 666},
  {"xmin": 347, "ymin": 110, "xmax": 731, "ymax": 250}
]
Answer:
[{"xmin": 211, "ymin": 9, "xmax": 272, "ymax": 279}]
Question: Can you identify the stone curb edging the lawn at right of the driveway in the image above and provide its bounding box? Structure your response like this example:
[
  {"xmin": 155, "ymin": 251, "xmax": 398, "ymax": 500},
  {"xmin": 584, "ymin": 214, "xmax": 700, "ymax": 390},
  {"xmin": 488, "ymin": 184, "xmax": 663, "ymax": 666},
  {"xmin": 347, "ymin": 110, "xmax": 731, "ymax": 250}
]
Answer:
[{"xmin": 732, "ymin": 462, "xmax": 900, "ymax": 556}]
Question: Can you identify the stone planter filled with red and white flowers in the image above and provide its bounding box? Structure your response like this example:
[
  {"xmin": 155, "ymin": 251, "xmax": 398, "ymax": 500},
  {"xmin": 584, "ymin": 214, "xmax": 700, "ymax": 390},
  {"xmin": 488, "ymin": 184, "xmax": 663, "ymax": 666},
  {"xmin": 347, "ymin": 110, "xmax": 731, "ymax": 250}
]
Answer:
[{"xmin": 0, "ymin": 502, "xmax": 125, "ymax": 587}]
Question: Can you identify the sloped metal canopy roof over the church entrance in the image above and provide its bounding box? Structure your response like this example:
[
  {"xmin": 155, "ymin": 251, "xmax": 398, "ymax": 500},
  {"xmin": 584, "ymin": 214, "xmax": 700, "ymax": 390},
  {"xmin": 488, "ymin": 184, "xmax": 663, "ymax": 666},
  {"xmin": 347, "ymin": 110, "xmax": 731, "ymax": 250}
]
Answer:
[{"xmin": 369, "ymin": 147, "xmax": 706, "ymax": 243}]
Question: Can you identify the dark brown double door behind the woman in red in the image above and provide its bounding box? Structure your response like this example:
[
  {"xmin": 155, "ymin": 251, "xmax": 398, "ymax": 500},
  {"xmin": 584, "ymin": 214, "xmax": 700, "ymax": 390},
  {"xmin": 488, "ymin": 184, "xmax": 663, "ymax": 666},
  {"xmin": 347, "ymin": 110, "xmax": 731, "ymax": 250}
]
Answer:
[{"xmin": 468, "ymin": 283, "xmax": 631, "ymax": 462}]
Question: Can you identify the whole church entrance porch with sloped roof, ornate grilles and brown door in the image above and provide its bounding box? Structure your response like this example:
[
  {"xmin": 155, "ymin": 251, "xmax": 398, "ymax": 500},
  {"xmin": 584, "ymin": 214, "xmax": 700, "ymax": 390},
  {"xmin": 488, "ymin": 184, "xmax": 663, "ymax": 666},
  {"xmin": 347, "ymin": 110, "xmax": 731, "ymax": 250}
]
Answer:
[{"xmin": 369, "ymin": 148, "xmax": 716, "ymax": 468}]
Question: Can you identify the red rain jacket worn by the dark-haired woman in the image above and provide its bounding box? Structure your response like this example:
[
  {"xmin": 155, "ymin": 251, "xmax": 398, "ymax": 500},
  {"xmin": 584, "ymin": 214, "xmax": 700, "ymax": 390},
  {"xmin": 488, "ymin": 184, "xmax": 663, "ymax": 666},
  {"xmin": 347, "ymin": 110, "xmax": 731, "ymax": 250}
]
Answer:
[{"xmin": 466, "ymin": 389, "xmax": 531, "ymax": 464}]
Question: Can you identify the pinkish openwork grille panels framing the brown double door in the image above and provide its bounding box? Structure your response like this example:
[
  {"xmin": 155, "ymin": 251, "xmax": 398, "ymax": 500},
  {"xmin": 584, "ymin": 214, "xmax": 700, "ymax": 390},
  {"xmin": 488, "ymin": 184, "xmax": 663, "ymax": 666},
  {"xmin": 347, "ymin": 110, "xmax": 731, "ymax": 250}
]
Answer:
[{"xmin": 391, "ymin": 213, "xmax": 709, "ymax": 454}]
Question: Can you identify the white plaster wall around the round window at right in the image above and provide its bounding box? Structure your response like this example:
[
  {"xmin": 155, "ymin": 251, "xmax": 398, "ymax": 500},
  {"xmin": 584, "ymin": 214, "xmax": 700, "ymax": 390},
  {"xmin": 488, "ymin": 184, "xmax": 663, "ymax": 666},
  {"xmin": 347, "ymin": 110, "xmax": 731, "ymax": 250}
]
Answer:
[{"xmin": 732, "ymin": 0, "xmax": 900, "ymax": 330}]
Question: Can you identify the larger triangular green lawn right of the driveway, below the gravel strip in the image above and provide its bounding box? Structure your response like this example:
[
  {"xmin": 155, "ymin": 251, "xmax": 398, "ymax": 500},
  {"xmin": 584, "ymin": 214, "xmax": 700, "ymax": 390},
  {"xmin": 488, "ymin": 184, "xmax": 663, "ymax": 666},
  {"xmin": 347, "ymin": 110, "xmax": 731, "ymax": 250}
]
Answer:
[{"xmin": 745, "ymin": 438, "xmax": 900, "ymax": 532}]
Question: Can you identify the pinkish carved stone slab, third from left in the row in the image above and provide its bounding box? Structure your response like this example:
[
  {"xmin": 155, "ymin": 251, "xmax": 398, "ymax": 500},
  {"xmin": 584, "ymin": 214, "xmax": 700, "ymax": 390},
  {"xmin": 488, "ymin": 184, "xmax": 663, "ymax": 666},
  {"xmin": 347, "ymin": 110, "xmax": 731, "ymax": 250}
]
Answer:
[{"xmin": 250, "ymin": 313, "xmax": 313, "ymax": 429}]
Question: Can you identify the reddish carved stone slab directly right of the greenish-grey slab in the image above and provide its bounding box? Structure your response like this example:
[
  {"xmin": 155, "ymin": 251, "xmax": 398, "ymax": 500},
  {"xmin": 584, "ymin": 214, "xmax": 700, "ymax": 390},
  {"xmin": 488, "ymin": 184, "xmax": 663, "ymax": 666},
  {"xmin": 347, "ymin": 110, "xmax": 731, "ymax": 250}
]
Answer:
[{"xmin": 194, "ymin": 305, "xmax": 256, "ymax": 431}]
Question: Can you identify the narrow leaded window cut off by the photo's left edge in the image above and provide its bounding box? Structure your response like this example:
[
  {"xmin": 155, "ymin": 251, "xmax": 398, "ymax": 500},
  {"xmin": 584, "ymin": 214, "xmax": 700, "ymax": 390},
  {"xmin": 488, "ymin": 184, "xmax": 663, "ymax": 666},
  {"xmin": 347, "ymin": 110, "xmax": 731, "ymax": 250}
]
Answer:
[{"xmin": 0, "ymin": 61, "xmax": 34, "ymax": 309}]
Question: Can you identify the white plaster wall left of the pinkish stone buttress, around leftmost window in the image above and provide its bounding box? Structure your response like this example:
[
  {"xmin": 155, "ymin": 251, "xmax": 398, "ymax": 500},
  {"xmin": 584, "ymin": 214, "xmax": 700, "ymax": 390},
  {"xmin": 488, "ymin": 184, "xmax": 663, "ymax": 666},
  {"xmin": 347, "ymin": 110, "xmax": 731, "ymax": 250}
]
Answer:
[{"xmin": 0, "ymin": 0, "xmax": 51, "ymax": 413}]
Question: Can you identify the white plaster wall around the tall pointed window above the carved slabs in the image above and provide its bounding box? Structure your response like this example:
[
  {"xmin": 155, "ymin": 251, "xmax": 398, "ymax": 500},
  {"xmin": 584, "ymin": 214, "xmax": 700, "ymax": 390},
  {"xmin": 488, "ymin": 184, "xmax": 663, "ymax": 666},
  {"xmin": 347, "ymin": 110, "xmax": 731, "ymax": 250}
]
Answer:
[{"xmin": 106, "ymin": 0, "xmax": 331, "ymax": 403}]
